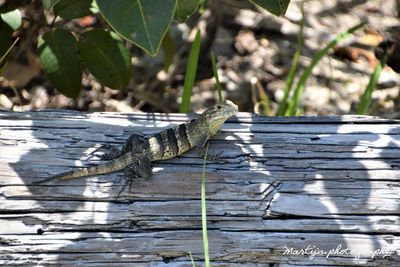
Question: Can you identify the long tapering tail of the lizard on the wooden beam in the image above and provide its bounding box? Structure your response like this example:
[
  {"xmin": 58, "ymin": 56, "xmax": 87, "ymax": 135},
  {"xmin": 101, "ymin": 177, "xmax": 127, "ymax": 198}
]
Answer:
[{"xmin": 32, "ymin": 155, "xmax": 129, "ymax": 184}]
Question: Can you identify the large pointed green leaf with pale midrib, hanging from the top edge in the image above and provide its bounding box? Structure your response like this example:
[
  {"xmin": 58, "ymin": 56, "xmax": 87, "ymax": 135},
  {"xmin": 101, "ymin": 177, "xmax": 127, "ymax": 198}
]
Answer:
[{"xmin": 96, "ymin": 0, "xmax": 176, "ymax": 56}]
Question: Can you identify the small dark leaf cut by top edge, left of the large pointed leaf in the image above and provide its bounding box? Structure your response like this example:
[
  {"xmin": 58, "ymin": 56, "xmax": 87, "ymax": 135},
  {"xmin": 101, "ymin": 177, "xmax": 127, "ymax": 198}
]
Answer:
[{"xmin": 54, "ymin": 0, "xmax": 92, "ymax": 19}]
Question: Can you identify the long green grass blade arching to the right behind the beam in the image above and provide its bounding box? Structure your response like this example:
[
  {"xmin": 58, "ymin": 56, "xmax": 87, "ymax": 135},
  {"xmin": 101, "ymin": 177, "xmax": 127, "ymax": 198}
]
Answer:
[{"xmin": 285, "ymin": 22, "xmax": 365, "ymax": 116}]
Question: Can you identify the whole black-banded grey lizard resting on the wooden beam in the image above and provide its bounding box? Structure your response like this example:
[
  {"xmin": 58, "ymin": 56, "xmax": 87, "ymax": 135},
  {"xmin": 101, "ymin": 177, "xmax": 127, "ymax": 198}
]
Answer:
[{"xmin": 33, "ymin": 100, "xmax": 238, "ymax": 191}]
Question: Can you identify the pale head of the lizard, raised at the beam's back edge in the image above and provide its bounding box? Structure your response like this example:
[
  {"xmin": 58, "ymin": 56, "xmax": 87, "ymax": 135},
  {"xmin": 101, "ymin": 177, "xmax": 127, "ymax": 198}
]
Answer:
[{"xmin": 202, "ymin": 100, "xmax": 238, "ymax": 135}]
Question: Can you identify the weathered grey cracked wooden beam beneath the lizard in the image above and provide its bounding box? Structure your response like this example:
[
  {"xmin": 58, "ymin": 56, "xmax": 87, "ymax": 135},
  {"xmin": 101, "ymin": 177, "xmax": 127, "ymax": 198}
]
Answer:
[{"xmin": 0, "ymin": 111, "xmax": 400, "ymax": 266}]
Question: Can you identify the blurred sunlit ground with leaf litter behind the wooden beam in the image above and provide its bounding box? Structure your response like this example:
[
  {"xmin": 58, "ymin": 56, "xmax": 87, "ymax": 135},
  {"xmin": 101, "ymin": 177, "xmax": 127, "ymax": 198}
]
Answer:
[{"xmin": 0, "ymin": 0, "xmax": 400, "ymax": 118}]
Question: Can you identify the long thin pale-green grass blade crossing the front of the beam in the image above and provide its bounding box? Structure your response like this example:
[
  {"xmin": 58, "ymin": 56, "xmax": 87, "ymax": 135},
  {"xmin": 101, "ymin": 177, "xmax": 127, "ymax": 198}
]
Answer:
[{"xmin": 201, "ymin": 144, "xmax": 210, "ymax": 267}]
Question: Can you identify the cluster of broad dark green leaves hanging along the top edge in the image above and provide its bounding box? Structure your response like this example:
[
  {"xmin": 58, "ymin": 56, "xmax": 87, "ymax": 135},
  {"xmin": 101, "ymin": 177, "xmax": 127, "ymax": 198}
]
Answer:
[{"xmin": 0, "ymin": 0, "xmax": 289, "ymax": 97}]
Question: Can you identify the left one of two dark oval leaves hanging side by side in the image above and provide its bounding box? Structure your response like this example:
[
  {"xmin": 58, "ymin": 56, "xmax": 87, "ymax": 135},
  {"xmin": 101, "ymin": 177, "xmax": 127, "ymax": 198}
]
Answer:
[{"xmin": 38, "ymin": 29, "xmax": 82, "ymax": 97}]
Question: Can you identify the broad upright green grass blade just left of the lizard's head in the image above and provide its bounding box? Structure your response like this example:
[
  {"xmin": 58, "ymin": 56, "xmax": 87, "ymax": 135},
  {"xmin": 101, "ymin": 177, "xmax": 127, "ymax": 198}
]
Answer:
[{"xmin": 179, "ymin": 30, "xmax": 201, "ymax": 113}]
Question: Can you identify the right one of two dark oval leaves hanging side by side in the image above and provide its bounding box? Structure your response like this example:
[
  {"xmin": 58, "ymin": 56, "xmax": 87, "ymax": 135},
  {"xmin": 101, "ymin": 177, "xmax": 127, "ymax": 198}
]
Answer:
[{"xmin": 78, "ymin": 30, "xmax": 132, "ymax": 88}]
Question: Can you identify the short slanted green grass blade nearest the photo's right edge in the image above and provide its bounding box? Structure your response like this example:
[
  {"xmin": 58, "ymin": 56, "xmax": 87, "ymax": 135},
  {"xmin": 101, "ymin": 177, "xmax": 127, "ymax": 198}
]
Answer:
[{"xmin": 357, "ymin": 49, "xmax": 389, "ymax": 115}]
